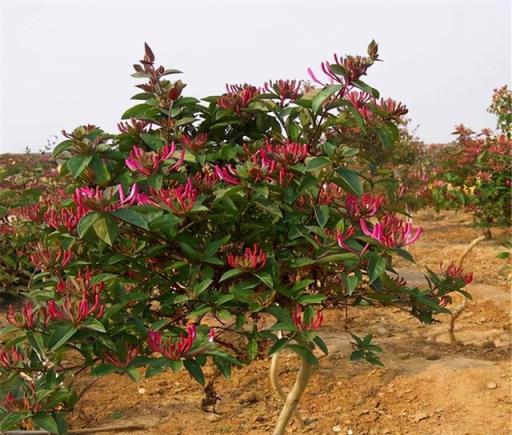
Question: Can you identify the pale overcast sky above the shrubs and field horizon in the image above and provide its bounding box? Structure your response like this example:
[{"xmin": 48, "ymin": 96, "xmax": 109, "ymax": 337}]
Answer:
[{"xmin": 0, "ymin": 0, "xmax": 512, "ymax": 152}]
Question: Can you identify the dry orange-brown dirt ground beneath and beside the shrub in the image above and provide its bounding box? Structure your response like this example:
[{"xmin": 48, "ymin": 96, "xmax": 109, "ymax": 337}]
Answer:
[{"xmin": 66, "ymin": 212, "xmax": 512, "ymax": 435}]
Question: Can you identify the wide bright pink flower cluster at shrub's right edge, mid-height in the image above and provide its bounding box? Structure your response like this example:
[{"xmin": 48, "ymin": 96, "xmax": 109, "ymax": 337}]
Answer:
[{"xmin": 359, "ymin": 214, "xmax": 422, "ymax": 248}]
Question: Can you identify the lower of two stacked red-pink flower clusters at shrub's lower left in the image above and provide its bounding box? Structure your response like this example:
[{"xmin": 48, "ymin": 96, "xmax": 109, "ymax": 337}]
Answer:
[{"xmin": 47, "ymin": 292, "xmax": 105, "ymax": 325}]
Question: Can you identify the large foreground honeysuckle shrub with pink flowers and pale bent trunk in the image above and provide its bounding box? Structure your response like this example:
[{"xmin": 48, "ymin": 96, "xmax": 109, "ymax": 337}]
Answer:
[{"xmin": 0, "ymin": 43, "xmax": 464, "ymax": 434}]
